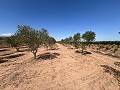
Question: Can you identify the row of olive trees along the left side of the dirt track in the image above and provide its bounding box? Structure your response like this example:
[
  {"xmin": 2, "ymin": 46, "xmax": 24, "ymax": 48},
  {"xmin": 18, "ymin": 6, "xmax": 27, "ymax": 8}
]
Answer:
[{"xmin": 6, "ymin": 25, "xmax": 56, "ymax": 58}]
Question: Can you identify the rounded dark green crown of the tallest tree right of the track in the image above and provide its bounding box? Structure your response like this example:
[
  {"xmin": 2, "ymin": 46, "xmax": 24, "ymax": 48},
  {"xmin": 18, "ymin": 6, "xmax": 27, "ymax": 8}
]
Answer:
[{"xmin": 82, "ymin": 31, "xmax": 96, "ymax": 42}]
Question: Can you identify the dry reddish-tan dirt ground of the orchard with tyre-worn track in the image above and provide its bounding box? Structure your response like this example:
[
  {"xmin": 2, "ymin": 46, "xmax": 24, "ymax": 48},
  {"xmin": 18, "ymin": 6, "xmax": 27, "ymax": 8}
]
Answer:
[{"xmin": 0, "ymin": 44, "xmax": 120, "ymax": 90}]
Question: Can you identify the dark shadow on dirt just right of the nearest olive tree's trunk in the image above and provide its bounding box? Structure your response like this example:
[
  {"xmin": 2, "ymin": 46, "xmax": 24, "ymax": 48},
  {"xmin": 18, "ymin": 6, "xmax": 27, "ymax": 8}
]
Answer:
[{"xmin": 37, "ymin": 52, "xmax": 60, "ymax": 60}]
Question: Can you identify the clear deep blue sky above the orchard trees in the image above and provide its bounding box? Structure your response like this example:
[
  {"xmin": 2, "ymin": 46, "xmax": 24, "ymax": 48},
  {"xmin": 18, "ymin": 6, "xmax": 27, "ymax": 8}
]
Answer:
[{"xmin": 0, "ymin": 0, "xmax": 120, "ymax": 41}]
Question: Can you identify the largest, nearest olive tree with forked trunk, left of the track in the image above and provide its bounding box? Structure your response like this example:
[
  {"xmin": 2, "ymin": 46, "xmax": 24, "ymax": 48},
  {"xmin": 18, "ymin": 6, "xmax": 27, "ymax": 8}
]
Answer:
[{"xmin": 17, "ymin": 25, "xmax": 41, "ymax": 58}]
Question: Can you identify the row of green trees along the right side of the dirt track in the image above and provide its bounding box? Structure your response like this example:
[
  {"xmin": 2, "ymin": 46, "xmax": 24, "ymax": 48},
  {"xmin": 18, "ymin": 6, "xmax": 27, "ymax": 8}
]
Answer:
[{"xmin": 61, "ymin": 31, "xmax": 96, "ymax": 52}]
